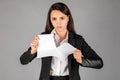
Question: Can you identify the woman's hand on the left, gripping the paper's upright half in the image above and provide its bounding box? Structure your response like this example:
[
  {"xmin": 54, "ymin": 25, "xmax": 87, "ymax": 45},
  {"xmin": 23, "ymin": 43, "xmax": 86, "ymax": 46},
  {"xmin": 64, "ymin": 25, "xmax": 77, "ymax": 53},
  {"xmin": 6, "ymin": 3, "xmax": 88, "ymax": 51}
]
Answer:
[{"xmin": 30, "ymin": 36, "xmax": 39, "ymax": 54}]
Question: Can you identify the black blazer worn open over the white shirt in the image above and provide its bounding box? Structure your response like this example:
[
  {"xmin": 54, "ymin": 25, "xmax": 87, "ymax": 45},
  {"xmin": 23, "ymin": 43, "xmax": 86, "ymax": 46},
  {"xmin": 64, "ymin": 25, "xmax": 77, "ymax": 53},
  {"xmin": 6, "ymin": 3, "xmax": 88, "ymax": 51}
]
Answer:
[{"xmin": 20, "ymin": 32, "xmax": 103, "ymax": 80}]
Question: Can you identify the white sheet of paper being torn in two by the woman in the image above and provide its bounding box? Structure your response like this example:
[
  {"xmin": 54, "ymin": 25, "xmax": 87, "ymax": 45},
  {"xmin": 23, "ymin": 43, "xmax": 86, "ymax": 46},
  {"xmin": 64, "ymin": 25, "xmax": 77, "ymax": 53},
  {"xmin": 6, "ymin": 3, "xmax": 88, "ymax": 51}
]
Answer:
[{"xmin": 37, "ymin": 34, "xmax": 76, "ymax": 59}]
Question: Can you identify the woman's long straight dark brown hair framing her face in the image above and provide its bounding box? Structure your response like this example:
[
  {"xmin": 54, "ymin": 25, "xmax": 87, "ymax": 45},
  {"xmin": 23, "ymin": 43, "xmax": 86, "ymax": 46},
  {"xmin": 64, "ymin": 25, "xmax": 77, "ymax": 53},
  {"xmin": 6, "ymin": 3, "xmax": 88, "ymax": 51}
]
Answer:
[{"xmin": 45, "ymin": 2, "xmax": 75, "ymax": 33}]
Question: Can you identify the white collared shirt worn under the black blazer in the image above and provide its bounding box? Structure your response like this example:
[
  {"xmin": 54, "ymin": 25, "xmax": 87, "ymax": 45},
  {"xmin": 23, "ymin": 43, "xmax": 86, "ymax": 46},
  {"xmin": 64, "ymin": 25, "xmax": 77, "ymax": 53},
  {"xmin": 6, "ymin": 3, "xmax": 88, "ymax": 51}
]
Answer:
[{"xmin": 50, "ymin": 29, "xmax": 69, "ymax": 76}]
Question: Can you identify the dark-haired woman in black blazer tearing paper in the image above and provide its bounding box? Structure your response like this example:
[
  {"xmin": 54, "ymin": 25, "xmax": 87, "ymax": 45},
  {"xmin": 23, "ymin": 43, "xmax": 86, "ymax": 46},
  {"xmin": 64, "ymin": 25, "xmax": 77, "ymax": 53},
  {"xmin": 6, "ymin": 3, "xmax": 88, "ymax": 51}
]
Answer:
[{"xmin": 20, "ymin": 3, "xmax": 103, "ymax": 80}]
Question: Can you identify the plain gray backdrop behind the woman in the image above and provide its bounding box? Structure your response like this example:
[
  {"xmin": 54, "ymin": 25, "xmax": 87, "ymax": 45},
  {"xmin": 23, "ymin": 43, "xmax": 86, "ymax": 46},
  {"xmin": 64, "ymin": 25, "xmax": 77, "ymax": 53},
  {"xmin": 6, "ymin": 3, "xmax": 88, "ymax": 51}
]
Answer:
[{"xmin": 0, "ymin": 0, "xmax": 120, "ymax": 80}]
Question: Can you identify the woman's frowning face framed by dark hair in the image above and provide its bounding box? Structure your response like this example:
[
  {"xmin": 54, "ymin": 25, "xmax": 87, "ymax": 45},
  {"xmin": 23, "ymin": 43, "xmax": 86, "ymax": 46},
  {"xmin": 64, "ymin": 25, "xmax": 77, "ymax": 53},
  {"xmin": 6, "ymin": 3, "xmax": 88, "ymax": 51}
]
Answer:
[{"xmin": 50, "ymin": 10, "xmax": 69, "ymax": 32}]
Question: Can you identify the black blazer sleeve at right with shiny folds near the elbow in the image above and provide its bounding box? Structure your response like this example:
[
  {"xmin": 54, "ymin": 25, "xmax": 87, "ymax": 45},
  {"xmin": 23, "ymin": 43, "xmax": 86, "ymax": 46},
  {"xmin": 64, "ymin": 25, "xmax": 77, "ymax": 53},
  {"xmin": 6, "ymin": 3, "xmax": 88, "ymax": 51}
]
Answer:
[{"xmin": 77, "ymin": 37, "xmax": 103, "ymax": 69}]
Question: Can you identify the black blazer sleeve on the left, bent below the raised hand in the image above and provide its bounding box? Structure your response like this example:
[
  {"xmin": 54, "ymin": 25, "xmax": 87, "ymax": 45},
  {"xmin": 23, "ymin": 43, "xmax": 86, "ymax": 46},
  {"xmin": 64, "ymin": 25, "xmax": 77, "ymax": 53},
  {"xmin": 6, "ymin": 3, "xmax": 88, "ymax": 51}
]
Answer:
[{"xmin": 20, "ymin": 48, "xmax": 37, "ymax": 65}]
